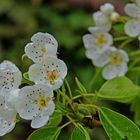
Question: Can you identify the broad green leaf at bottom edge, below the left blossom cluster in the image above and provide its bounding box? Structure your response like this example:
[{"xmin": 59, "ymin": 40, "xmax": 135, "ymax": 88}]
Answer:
[{"xmin": 27, "ymin": 127, "xmax": 61, "ymax": 140}]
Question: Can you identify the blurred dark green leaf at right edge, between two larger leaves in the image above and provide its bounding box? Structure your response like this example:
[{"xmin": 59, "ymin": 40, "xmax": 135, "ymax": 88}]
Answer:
[{"xmin": 131, "ymin": 96, "xmax": 140, "ymax": 126}]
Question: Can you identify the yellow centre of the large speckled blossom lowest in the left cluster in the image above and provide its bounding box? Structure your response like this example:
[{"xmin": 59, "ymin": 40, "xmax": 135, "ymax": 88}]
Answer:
[{"xmin": 37, "ymin": 96, "xmax": 50, "ymax": 108}]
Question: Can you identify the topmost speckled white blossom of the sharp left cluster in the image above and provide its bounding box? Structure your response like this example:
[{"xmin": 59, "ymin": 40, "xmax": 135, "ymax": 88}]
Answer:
[{"xmin": 25, "ymin": 32, "xmax": 58, "ymax": 63}]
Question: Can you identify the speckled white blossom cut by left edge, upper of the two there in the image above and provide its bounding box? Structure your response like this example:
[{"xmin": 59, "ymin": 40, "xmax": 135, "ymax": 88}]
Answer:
[{"xmin": 0, "ymin": 61, "xmax": 22, "ymax": 93}]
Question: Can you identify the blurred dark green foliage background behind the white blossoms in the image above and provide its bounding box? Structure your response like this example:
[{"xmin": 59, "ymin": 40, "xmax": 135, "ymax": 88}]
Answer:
[{"xmin": 0, "ymin": 0, "xmax": 129, "ymax": 140}]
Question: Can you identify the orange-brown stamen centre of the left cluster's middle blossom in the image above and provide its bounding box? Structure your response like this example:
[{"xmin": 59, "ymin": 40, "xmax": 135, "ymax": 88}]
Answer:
[{"xmin": 45, "ymin": 70, "xmax": 58, "ymax": 85}]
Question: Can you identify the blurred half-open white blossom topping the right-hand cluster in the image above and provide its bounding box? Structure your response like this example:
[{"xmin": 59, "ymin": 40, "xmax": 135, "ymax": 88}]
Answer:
[{"xmin": 93, "ymin": 3, "xmax": 119, "ymax": 31}]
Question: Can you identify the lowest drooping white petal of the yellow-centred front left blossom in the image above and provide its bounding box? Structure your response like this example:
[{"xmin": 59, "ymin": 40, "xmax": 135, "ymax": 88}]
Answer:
[{"xmin": 31, "ymin": 115, "xmax": 49, "ymax": 128}]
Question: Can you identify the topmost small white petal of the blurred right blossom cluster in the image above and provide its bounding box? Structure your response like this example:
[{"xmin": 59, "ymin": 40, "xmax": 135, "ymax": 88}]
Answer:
[{"xmin": 100, "ymin": 3, "xmax": 114, "ymax": 15}]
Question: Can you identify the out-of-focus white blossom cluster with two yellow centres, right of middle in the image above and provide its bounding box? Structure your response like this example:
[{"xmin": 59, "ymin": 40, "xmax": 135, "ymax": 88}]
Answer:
[{"xmin": 83, "ymin": 3, "xmax": 129, "ymax": 80}]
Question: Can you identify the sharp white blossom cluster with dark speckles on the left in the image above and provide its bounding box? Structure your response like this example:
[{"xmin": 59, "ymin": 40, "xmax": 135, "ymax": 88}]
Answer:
[{"xmin": 0, "ymin": 32, "xmax": 67, "ymax": 136}]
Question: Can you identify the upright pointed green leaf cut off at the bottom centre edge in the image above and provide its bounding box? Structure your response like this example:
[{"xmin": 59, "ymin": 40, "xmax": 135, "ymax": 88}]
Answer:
[{"xmin": 71, "ymin": 124, "xmax": 90, "ymax": 140}]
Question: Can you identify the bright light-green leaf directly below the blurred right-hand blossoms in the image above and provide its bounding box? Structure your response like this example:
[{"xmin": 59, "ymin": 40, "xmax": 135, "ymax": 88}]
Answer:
[{"xmin": 98, "ymin": 77, "xmax": 140, "ymax": 103}]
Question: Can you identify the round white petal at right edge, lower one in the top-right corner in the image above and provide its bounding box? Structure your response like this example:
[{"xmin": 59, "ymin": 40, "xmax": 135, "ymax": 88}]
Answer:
[{"xmin": 124, "ymin": 20, "xmax": 140, "ymax": 37}]
